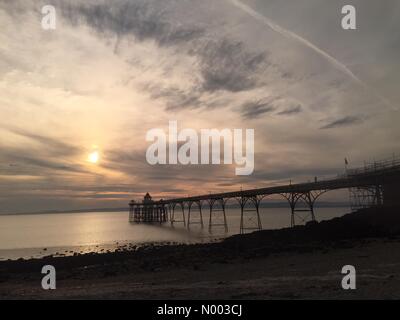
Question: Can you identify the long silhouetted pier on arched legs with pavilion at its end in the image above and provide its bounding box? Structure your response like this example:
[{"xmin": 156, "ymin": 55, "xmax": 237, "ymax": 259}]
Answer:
[{"xmin": 129, "ymin": 158, "xmax": 400, "ymax": 233}]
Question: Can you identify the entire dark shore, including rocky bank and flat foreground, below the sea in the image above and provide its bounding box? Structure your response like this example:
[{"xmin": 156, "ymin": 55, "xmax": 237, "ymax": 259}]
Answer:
[{"xmin": 0, "ymin": 209, "xmax": 400, "ymax": 299}]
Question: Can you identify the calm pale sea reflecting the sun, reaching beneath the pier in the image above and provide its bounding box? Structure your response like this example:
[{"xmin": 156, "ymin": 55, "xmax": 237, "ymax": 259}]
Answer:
[{"xmin": 0, "ymin": 207, "xmax": 350, "ymax": 260}]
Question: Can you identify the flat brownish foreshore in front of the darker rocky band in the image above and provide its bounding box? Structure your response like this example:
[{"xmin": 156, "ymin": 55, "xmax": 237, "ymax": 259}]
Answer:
[{"xmin": 0, "ymin": 238, "xmax": 400, "ymax": 299}]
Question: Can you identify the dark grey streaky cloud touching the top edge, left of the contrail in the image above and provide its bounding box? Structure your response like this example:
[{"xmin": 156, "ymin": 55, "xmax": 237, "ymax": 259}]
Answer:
[{"xmin": 61, "ymin": 0, "xmax": 204, "ymax": 46}]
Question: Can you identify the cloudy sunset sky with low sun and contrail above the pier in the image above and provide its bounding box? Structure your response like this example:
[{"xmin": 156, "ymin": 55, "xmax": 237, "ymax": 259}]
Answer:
[{"xmin": 0, "ymin": 0, "xmax": 400, "ymax": 213}]
